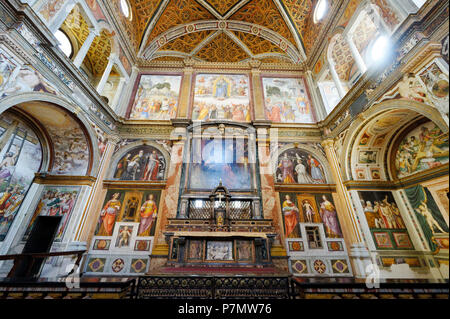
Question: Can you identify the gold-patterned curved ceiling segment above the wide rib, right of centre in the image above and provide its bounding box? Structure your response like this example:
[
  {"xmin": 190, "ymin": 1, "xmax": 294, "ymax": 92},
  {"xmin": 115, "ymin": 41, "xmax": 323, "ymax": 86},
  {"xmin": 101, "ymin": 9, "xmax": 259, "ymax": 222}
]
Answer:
[{"xmin": 230, "ymin": 0, "xmax": 295, "ymax": 45}]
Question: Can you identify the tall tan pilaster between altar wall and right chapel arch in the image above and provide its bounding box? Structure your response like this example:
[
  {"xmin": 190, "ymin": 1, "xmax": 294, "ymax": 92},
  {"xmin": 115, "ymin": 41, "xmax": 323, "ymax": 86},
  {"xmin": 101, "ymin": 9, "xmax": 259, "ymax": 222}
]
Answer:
[{"xmin": 322, "ymin": 139, "xmax": 371, "ymax": 278}]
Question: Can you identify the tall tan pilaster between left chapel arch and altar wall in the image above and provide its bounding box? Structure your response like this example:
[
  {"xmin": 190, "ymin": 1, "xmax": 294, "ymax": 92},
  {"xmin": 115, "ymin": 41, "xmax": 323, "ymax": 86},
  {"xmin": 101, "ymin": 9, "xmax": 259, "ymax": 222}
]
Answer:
[{"xmin": 74, "ymin": 136, "xmax": 120, "ymax": 247}]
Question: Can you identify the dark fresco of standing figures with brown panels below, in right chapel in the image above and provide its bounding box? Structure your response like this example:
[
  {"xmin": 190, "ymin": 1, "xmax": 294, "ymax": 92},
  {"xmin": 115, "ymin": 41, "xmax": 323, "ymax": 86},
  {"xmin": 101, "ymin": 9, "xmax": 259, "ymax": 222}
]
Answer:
[{"xmin": 359, "ymin": 191, "xmax": 414, "ymax": 250}]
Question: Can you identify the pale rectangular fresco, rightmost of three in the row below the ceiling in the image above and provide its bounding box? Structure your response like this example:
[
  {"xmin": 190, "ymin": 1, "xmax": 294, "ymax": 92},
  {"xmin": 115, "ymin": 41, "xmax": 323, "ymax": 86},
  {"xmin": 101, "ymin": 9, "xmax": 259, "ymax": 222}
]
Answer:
[{"xmin": 262, "ymin": 77, "xmax": 315, "ymax": 123}]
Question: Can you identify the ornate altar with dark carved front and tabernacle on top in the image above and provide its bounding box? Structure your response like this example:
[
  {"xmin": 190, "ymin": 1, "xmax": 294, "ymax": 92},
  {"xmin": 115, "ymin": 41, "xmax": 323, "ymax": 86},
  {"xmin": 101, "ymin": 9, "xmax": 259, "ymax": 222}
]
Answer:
[{"xmin": 165, "ymin": 182, "xmax": 276, "ymax": 267}]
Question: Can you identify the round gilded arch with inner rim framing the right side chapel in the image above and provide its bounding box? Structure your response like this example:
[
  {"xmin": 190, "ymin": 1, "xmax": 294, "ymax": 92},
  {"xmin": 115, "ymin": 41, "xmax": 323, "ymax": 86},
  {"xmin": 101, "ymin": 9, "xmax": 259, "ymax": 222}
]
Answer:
[{"xmin": 339, "ymin": 99, "xmax": 449, "ymax": 180}]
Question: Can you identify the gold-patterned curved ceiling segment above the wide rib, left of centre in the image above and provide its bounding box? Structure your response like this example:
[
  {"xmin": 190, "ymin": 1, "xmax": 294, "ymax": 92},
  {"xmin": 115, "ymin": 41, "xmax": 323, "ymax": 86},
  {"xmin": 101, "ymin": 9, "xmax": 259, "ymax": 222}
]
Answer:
[{"xmin": 147, "ymin": 0, "xmax": 214, "ymax": 45}]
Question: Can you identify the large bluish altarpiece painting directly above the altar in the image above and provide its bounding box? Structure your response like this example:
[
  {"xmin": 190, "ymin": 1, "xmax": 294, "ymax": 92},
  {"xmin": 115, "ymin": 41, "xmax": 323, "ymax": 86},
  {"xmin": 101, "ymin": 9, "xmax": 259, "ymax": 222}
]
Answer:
[{"xmin": 189, "ymin": 139, "xmax": 253, "ymax": 190}]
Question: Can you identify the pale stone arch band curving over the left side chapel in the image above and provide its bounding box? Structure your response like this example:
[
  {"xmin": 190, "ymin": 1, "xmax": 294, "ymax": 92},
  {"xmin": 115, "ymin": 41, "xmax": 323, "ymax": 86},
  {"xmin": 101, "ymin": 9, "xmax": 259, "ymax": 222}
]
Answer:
[{"xmin": 0, "ymin": 92, "xmax": 100, "ymax": 176}]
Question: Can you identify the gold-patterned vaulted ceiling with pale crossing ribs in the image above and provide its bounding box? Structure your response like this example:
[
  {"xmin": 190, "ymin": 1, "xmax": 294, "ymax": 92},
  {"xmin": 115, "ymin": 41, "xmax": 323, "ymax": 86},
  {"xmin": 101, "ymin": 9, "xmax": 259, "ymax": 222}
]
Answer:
[{"xmin": 95, "ymin": 0, "xmax": 335, "ymax": 63}]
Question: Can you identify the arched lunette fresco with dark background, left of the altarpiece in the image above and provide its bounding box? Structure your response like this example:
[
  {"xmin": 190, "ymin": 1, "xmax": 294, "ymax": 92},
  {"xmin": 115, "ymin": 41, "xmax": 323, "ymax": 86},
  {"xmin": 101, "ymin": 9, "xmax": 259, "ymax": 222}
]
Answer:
[{"xmin": 114, "ymin": 145, "xmax": 166, "ymax": 181}]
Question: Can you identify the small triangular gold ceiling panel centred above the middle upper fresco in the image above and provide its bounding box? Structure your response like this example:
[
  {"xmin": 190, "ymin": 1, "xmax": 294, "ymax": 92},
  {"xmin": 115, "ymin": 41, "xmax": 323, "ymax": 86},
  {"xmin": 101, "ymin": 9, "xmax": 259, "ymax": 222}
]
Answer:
[{"xmin": 197, "ymin": 33, "xmax": 249, "ymax": 62}]
